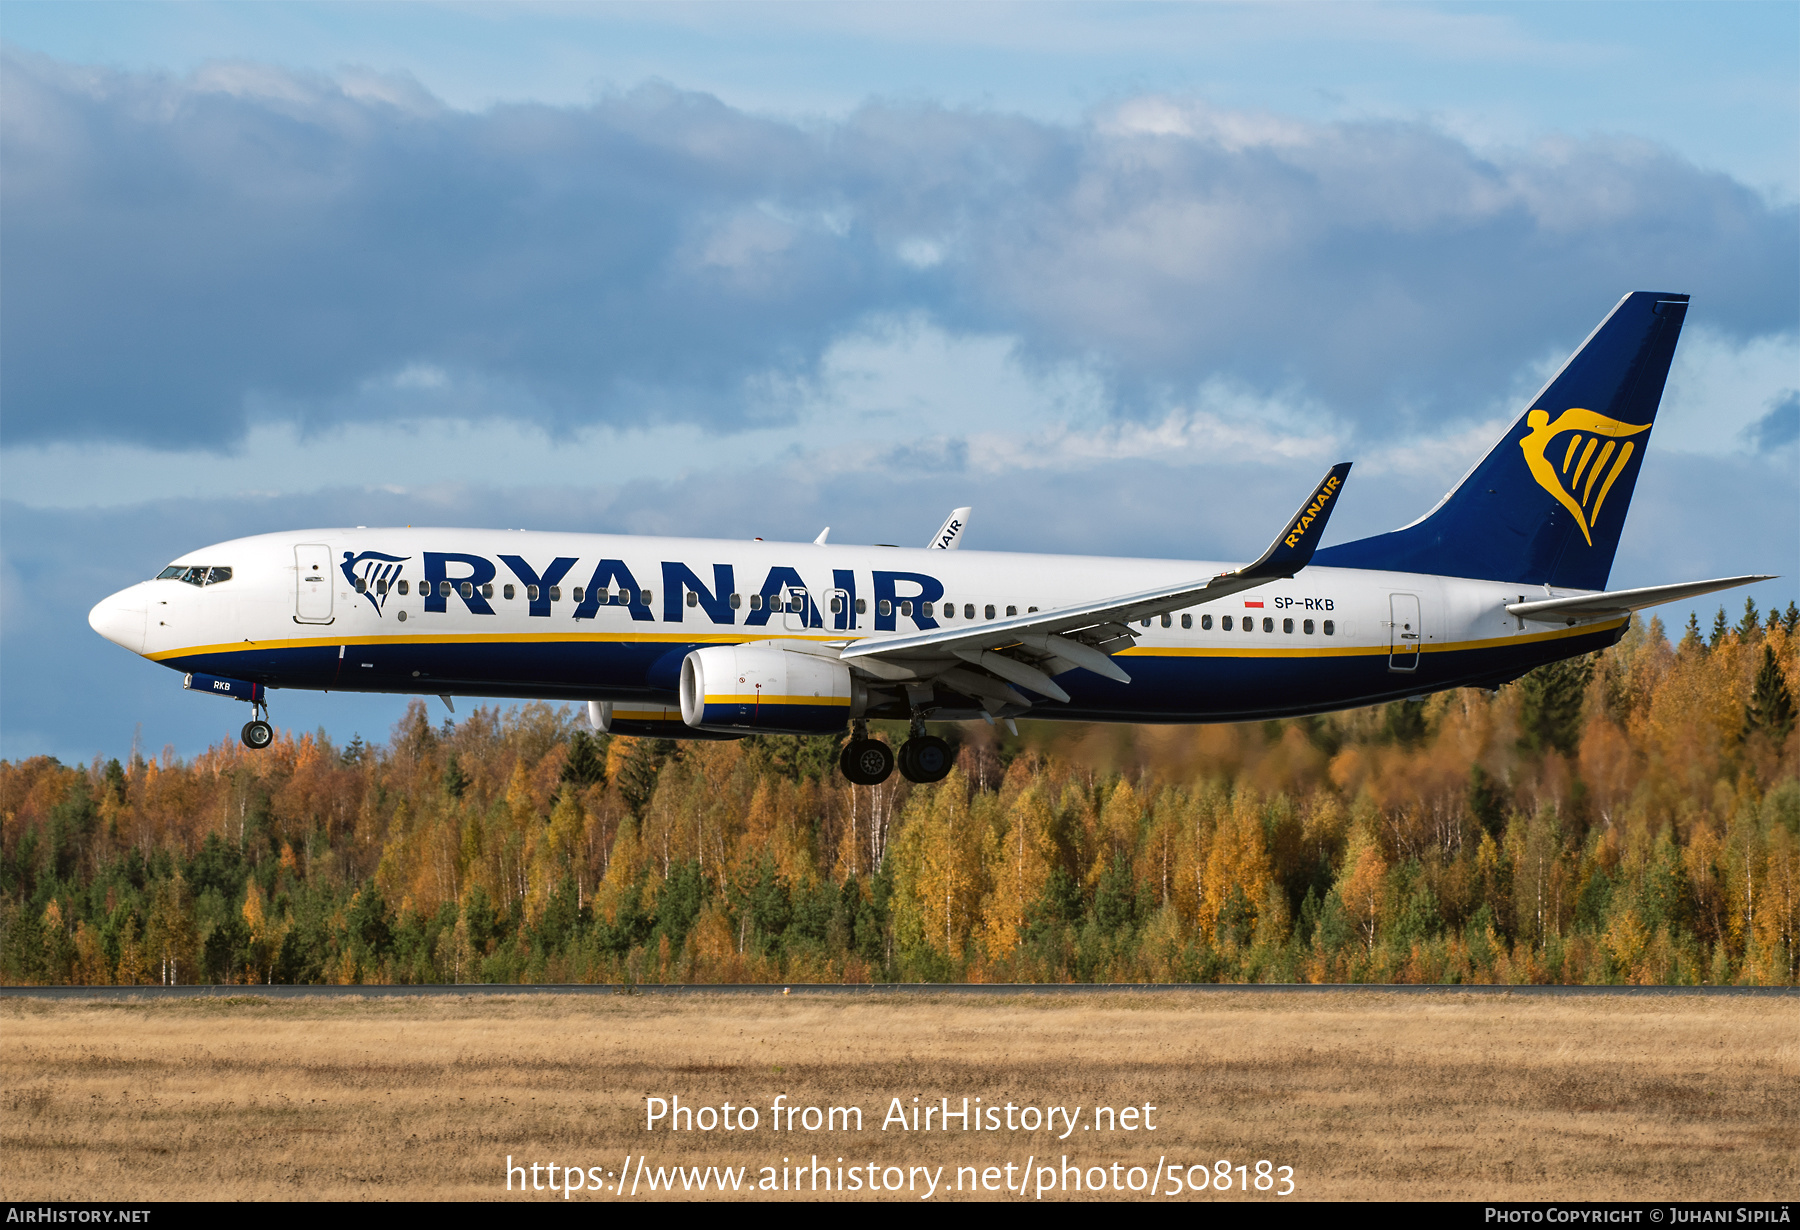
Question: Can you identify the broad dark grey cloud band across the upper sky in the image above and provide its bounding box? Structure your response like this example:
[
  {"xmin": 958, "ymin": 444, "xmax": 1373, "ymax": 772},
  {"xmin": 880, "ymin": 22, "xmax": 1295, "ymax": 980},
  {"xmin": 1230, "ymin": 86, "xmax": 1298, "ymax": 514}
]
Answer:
[{"xmin": 0, "ymin": 54, "xmax": 1800, "ymax": 447}]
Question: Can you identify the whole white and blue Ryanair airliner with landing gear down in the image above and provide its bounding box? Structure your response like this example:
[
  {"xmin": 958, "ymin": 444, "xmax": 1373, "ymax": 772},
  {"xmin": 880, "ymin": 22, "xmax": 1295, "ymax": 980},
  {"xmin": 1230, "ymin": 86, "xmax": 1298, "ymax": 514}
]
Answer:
[{"xmin": 88, "ymin": 292, "xmax": 1766, "ymax": 783}]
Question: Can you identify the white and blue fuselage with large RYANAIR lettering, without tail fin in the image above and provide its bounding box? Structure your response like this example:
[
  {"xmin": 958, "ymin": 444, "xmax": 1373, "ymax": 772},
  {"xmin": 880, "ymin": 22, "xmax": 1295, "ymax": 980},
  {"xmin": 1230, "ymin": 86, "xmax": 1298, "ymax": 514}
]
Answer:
[{"xmin": 90, "ymin": 528, "xmax": 1624, "ymax": 722}]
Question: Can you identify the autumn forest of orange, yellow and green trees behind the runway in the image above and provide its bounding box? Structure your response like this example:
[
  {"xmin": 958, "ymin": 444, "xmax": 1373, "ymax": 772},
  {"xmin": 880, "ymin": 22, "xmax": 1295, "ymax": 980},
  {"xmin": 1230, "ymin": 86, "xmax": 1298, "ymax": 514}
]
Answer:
[{"xmin": 0, "ymin": 603, "xmax": 1800, "ymax": 983}]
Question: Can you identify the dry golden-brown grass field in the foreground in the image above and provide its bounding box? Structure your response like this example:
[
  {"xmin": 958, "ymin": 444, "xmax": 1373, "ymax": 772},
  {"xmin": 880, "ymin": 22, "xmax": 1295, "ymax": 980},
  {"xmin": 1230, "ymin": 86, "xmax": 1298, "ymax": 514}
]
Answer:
[{"xmin": 0, "ymin": 990, "xmax": 1800, "ymax": 1199}]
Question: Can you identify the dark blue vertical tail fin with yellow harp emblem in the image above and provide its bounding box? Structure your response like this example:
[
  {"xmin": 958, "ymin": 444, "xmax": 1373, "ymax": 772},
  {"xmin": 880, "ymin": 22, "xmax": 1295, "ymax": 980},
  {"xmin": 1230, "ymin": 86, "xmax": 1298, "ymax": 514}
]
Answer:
[{"xmin": 1312, "ymin": 290, "xmax": 1688, "ymax": 589}]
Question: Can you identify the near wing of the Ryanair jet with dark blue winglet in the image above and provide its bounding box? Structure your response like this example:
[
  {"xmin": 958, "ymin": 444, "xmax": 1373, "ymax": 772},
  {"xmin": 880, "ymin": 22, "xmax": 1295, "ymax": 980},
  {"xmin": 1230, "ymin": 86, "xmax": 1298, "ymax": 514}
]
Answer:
[{"xmin": 841, "ymin": 461, "xmax": 1350, "ymax": 701}]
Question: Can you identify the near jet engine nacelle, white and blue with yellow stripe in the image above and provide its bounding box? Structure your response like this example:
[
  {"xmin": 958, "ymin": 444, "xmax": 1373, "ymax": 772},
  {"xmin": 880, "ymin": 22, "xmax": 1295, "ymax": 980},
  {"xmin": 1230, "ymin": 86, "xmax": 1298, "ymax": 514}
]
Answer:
[{"xmin": 680, "ymin": 641, "xmax": 868, "ymax": 735}]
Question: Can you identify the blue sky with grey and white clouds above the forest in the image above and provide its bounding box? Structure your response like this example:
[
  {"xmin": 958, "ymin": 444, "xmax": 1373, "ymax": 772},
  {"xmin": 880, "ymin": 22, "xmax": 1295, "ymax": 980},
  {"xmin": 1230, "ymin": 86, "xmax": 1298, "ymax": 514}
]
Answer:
[{"xmin": 0, "ymin": 0, "xmax": 1800, "ymax": 760}]
